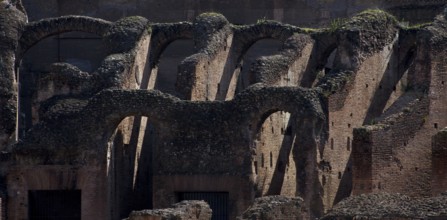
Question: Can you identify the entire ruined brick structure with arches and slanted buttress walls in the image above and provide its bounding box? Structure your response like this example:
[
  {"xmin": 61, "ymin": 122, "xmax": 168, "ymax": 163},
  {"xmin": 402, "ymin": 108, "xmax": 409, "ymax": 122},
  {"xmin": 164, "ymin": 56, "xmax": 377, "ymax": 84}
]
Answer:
[{"xmin": 4, "ymin": 4, "xmax": 447, "ymax": 219}]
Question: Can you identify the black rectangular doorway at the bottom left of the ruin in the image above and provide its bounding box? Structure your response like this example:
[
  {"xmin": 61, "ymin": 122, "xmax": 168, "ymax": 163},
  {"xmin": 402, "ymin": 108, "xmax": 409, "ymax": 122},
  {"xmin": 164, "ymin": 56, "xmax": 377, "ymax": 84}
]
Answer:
[{"xmin": 28, "ymin": 190, "xmax": 81, "ymax": 220}]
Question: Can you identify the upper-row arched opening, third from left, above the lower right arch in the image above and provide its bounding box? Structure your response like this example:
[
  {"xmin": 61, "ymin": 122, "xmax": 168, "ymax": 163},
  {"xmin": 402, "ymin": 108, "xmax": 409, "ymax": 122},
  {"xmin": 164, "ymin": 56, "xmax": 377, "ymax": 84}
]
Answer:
[{"xmin": 233, "ymin": 39, "xmax": 282, "ymax": 96}]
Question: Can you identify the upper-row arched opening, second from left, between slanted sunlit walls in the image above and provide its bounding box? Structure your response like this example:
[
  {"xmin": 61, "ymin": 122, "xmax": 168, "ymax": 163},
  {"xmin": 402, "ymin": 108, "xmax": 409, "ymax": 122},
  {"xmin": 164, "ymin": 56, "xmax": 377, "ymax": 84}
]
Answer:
[{"xmin": 149, "ymin": 39, "xmax": 194, "ymax": 96}]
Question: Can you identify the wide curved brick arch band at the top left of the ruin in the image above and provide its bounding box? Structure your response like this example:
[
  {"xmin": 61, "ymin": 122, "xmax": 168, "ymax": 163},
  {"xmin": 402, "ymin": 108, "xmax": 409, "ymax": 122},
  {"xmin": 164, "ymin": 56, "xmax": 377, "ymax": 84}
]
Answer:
[{"xmin": 17, "ymin": 16, "xmax": 112, "ymax": 62}]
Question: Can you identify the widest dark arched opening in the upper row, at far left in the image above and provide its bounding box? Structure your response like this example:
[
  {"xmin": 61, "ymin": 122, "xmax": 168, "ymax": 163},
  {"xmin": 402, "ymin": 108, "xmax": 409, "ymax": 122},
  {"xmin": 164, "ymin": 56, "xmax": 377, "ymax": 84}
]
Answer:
[{"xmin": 18, "ymin": 32, "xmax": 106, "ymax": 137}]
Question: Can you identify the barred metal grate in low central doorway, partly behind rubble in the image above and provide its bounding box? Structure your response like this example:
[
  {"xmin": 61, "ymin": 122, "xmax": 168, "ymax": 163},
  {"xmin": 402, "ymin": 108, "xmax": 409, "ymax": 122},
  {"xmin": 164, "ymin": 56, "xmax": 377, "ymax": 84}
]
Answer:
[{"xmin": 178, "ymin": 192, "xmax": 229, "ymax": 220}]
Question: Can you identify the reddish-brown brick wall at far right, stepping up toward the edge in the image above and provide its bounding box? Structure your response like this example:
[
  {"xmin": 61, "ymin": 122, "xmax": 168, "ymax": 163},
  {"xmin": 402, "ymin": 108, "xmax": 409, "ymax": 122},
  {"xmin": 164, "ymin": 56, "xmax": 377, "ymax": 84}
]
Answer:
[{"xmin": 353, "ymin": 14, "xmax": 445, "ymax": 199}]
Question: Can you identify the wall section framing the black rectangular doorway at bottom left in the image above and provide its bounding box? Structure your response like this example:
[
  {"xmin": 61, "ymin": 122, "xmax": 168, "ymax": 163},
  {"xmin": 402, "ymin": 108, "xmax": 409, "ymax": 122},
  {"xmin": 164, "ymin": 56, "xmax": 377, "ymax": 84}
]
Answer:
[{"xmin": 7, "ymin": 166, "xmax": 111, "ymax": 219}]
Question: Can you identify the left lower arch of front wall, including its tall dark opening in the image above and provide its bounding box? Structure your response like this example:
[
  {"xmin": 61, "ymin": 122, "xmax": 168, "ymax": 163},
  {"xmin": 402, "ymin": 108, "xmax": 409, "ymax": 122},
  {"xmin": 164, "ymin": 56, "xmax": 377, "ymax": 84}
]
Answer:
[{"xmin": 83, "ymin": 90, "xmax": 175, "ymax": 218}]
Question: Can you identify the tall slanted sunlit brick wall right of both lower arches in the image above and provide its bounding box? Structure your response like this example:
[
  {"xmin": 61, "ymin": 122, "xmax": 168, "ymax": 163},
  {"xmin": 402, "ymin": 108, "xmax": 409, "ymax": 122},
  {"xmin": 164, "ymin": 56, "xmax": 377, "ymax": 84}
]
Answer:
[{"xmin": 320, "ymin": 9, "xmax": 398, "ymax": 207}]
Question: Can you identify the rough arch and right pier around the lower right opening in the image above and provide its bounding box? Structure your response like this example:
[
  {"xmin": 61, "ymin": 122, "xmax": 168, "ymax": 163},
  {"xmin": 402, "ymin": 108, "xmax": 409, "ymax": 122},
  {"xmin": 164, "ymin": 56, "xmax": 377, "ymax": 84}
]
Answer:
[{"xmin": 234, "ymin": 86, "xmax": 326, "ymax": 217}]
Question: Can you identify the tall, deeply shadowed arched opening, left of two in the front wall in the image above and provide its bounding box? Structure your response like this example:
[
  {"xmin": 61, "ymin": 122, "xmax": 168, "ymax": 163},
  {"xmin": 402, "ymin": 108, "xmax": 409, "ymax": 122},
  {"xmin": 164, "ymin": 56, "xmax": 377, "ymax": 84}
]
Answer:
[{"xmin": 106, "ymin": 116, "xmax": 157, "ymax": 219}]
